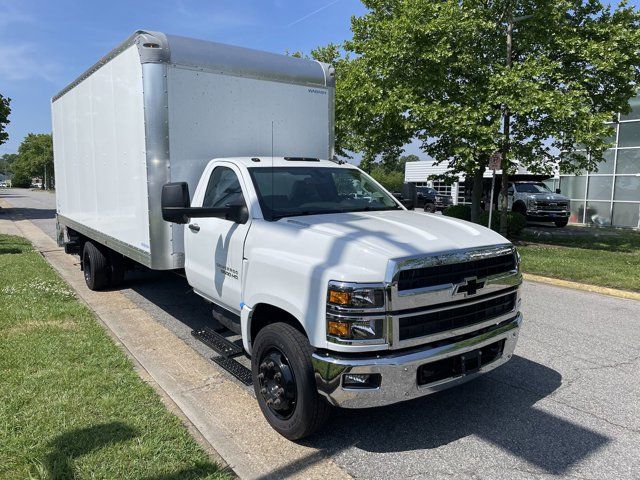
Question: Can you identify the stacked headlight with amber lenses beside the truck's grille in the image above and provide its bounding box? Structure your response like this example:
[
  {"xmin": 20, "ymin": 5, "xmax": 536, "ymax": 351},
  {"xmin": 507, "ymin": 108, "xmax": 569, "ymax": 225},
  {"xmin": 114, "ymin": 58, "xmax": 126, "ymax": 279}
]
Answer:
[{"xmin": 327, "ymin": 282, "xmax": 385, "ymax": 343}]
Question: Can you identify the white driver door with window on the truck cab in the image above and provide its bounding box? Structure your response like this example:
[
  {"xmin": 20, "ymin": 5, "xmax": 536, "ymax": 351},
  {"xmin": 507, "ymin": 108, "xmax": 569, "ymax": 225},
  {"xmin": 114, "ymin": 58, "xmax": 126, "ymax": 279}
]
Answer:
[{"xmin": 184, "ymin": 164, "xmax": 251, "ymax": 313}]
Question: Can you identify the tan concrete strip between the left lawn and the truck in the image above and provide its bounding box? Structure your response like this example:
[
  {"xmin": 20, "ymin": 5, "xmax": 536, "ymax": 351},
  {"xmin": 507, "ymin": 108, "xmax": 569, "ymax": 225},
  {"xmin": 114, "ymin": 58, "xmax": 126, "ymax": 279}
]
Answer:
[{"xmin": 0, "ymin": 200, "xmax": 350, "ymax": 479}]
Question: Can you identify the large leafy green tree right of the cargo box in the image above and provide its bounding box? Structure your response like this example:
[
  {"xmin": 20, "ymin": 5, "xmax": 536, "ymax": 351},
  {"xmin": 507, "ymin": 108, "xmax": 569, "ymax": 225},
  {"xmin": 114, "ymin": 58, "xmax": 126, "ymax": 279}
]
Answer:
[{"xmin": 336, "ymin": 0, "xmax": 640, "ymax": 228}]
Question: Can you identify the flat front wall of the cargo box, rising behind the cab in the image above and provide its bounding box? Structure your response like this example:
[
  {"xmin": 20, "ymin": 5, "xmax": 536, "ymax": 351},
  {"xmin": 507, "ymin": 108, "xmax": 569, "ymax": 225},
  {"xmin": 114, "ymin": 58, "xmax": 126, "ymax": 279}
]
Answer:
[{"xmin": 167, "ymin": 66, "xmax": 333, "ymax": 252}]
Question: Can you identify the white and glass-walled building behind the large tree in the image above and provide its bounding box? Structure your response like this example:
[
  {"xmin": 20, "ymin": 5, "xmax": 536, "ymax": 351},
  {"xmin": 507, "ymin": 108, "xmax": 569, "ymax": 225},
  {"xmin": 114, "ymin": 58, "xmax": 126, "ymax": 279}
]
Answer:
[{"xmin": 405, "ymin": 97, "xmax": 640, "ymax": 228}]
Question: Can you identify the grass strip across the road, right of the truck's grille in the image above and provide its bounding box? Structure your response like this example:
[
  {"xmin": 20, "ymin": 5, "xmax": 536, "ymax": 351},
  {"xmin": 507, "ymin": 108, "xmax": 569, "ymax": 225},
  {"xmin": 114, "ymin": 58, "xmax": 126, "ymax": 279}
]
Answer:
[{"xmin": 518, "ymin": 227, "xmax": 640, "ymax": 292}]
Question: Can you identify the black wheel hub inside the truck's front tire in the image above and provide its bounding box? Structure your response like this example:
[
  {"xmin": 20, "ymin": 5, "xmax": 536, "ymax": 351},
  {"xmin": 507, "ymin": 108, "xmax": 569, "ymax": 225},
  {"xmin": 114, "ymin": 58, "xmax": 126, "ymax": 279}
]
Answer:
[{"xmin": 258, "ymin": 350, "xmax": 296, "ymax": 418}]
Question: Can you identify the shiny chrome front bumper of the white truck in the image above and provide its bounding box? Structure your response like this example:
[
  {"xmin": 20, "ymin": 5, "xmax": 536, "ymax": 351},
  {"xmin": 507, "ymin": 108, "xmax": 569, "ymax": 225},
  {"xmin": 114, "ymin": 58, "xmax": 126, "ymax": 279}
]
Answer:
[{"xmin": 312, "ymin": 313, "xmax": 522, "ymax": 408}]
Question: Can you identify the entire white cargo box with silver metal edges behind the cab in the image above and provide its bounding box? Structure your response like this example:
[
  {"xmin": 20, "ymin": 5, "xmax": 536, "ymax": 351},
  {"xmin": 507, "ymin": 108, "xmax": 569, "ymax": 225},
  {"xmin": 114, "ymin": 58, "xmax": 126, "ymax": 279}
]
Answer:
[{"xmin": 52, "ymin": 31, "xmax": 334, "ymax": 269}]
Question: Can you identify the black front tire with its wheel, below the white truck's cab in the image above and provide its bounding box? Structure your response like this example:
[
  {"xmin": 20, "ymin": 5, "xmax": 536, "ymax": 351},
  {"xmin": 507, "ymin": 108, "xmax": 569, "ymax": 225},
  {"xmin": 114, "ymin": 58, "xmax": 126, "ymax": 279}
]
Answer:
[{"xmin": 251, "ymin": 323, "xmax": 331, "ymax": 440}]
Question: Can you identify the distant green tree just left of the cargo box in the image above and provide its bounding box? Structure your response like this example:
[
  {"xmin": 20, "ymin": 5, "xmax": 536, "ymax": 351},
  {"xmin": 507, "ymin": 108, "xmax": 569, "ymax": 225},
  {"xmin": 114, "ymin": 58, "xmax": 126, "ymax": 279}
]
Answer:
[{"xmin": 12, "ymin": 133, "xmax": 54, "ymax": 188}]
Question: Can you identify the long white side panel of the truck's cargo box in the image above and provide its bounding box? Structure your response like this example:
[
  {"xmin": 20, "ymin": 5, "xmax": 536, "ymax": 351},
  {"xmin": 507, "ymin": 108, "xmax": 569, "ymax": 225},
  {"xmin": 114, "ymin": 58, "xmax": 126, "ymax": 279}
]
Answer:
[{"xmin": 52, "ymin": 46, "xmax": 150, "ymax": 252}]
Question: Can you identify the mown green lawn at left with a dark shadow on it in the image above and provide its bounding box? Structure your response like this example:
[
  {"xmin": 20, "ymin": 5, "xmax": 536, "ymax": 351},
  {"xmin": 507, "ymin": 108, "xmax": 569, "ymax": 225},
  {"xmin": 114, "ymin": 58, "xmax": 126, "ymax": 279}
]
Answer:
[{"xmin": 0, "ymin": 235, "xmax": 228, "ymax": 480}]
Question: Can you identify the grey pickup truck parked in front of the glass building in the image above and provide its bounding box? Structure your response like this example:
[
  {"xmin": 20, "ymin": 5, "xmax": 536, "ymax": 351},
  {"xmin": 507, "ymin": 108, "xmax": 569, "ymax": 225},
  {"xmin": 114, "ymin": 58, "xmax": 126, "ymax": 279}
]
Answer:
[{"xmin": 500, "ymin": 182, "xmax": 570, "ymax": 227}]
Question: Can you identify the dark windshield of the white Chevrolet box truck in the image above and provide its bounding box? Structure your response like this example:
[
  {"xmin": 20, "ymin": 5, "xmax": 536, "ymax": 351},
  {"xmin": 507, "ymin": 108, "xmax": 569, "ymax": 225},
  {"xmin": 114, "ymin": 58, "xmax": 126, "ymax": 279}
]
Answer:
[{"xmin": 249, "ymin": 167, "xmax": 401, "ymax": 220}]
